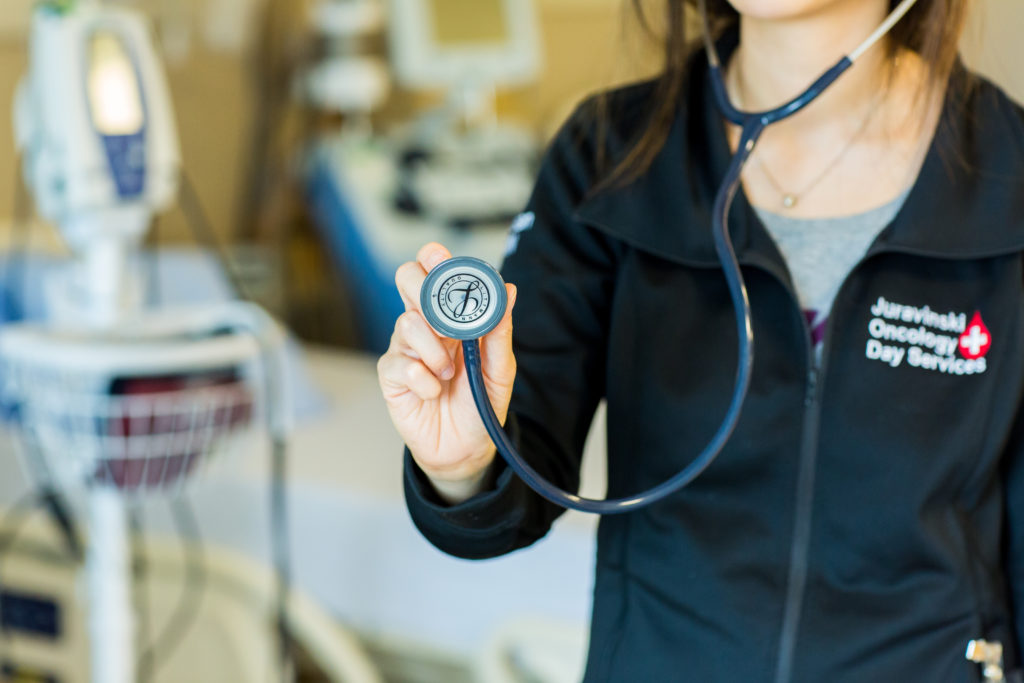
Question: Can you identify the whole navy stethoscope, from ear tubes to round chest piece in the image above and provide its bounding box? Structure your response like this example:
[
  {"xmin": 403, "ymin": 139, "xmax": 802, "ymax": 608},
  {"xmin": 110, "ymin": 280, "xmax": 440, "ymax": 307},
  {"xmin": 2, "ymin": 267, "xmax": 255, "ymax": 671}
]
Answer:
[{"xmin": 420, "ymin": 0, "xmax": 916, "ymax": 515}]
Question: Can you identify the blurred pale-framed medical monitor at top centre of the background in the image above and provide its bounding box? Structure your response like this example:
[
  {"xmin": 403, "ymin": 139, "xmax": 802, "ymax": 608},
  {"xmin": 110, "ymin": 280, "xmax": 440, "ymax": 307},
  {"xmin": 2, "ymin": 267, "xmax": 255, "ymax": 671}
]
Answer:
[{"xmin": 390, "ymin": 0, "xmax": 540, "ymax": 89}]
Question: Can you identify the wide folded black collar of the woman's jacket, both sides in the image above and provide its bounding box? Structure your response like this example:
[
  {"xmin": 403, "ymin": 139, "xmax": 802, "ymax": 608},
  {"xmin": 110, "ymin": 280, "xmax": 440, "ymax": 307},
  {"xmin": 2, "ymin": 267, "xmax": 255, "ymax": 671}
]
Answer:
[{"xmin": 575, "ymin": 37, "xmax": 1024, "ymax": 273}]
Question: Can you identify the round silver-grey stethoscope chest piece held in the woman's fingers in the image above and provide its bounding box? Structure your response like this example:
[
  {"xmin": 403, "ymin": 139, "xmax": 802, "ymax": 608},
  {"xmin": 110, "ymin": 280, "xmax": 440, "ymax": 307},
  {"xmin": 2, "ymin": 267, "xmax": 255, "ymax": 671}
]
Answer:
[{"xmin": 420, "ymin": 256, "xmax": 508, "ymax": 341}]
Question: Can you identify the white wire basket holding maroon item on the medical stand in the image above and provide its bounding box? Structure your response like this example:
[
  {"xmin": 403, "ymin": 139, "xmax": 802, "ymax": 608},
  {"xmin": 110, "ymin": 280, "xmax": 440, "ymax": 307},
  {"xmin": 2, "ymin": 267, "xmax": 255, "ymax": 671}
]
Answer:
[{"xmin": 0, "ymin": 313, "xmax": 259, "ymax": 495}]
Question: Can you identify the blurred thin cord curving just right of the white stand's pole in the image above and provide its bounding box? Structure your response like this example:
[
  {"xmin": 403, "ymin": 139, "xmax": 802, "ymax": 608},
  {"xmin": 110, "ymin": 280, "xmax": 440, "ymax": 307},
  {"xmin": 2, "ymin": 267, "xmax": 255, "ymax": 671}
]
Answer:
[{"xmin": 137, "ymin": 497, "xmax": 207, "ymax": 683}]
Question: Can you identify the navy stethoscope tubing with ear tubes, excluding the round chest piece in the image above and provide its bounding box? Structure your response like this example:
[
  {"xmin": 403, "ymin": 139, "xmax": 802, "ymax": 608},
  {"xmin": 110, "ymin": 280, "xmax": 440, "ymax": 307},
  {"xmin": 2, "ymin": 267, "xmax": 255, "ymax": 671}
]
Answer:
[{"xmin": 462, "ymin": 0, "xmax": 915, "ymax": 515}]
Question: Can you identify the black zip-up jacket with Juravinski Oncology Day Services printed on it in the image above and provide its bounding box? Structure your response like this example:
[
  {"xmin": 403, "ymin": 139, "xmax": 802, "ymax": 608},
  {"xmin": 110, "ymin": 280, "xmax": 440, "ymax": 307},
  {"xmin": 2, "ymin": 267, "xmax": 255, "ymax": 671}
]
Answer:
[{"xmin": 406, "ymin": 45, "xmax": 1024, "ymax": 683}]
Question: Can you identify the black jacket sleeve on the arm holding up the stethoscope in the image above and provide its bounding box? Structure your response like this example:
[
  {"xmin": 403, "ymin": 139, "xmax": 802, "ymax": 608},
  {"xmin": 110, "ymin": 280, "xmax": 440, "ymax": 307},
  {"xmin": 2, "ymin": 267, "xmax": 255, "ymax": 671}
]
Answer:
[{"xmin": 404, "ymin": 102, "xmax": 617, "ymax": 559}]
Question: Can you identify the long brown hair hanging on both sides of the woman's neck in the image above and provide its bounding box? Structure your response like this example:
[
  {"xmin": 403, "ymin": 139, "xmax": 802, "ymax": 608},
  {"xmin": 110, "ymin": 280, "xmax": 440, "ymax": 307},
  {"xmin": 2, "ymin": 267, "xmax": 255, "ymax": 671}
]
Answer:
[{"xmin": 595, "ymin": 0, "xmax": 968, "ymax": 191}]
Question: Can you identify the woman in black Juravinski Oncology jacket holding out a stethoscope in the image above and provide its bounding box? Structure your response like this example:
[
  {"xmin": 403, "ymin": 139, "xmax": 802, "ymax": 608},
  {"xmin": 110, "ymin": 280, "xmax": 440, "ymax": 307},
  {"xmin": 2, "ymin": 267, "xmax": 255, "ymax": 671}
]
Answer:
[{"xmin": 379, "ymin": 0, "xmax": 1024, "ymax": 683}]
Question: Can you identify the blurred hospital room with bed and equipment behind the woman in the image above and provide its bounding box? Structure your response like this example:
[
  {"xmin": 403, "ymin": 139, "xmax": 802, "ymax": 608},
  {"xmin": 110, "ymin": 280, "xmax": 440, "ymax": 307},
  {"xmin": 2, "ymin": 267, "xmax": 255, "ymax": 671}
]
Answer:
[{"xmin": 0, "ymin": 0, "xmax": 1024, "ymax": 683}]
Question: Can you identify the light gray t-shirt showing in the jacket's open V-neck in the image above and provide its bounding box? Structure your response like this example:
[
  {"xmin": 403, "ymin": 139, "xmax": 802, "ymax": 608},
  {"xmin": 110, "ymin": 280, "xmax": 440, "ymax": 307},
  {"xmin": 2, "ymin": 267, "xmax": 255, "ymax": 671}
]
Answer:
[{"xmin": 755, "ymin": 191, "xmax": 909, "ymax": 354}]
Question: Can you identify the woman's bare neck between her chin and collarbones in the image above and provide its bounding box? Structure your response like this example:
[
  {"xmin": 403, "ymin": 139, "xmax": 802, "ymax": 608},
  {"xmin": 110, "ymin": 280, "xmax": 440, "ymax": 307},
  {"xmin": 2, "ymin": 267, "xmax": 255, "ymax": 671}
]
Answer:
[{"xmin": 730, "ymin": 0, "xmax": 888, "ymax": 126}]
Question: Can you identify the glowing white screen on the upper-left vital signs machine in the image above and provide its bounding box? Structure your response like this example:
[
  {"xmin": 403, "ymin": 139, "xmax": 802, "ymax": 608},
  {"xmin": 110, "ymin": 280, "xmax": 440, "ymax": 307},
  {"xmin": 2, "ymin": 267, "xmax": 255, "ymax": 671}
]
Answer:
[{"xmin": 88, "ymin": 32, "xmax": 145, "ymax": 135}]
